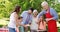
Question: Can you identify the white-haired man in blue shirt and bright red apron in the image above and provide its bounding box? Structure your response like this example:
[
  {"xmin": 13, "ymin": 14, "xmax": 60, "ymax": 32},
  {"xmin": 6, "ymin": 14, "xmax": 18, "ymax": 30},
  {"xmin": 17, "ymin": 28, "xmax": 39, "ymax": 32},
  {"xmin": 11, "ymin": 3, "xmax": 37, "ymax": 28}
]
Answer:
[{"xmin": 37, "ymin": 1, "xmax": 58, "ymax": 32}]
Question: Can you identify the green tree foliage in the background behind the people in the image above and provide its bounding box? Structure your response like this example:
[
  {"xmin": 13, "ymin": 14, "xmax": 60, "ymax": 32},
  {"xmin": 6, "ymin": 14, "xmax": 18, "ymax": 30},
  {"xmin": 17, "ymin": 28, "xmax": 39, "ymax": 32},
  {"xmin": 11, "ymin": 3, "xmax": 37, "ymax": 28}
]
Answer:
[{"xmin": 0, "ymin": 0, "xmax": 60, "ymax": 18}]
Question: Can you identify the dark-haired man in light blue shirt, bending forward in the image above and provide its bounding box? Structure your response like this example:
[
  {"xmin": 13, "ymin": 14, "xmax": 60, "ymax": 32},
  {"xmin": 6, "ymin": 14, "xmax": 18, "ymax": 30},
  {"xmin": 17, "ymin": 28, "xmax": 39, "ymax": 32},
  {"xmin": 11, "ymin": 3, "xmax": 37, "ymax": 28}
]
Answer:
[{"xmin": 21, "ymin": 8, "xmax": 33, "ymax": 32}]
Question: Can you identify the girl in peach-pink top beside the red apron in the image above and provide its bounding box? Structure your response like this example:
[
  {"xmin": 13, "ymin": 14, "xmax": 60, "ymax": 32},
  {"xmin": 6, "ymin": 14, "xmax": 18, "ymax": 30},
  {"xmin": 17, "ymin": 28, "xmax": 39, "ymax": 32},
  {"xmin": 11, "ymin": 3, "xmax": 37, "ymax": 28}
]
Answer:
[{"xmin": 38, "ymin": 16, "xmax": 47, "ymax": 32}]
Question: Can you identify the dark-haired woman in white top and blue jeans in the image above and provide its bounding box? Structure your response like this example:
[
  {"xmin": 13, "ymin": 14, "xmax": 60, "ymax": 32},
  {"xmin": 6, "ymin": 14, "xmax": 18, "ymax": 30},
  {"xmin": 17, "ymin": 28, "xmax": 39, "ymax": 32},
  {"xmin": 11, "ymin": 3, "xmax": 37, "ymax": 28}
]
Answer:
[{"xmin": 8, "ymin": 6, "xmax": 21, "ymax": 32}]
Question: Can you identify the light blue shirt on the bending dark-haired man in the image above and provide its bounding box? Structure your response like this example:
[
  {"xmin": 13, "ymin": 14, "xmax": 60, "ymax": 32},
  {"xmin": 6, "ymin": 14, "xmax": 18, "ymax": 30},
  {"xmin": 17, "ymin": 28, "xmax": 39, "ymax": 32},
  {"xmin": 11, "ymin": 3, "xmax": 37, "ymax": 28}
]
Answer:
[{"xmin": 21, "ymin": 11, "xmax": 32, "ymax": 24}]
